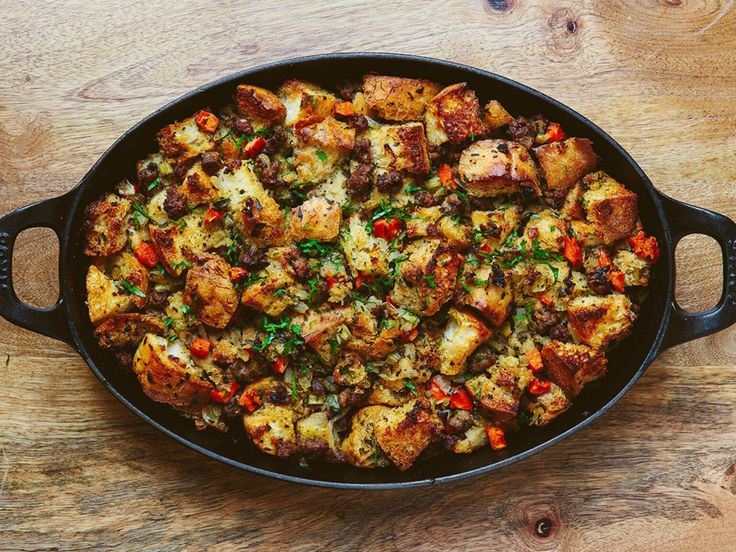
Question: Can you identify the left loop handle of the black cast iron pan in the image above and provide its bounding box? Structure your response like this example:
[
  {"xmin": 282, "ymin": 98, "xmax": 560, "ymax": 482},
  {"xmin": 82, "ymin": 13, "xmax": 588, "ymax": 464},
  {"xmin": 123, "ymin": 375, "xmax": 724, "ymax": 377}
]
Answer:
[{"xmin": 0, "ymin": 194, "xmax": 73, "ymax": 345}]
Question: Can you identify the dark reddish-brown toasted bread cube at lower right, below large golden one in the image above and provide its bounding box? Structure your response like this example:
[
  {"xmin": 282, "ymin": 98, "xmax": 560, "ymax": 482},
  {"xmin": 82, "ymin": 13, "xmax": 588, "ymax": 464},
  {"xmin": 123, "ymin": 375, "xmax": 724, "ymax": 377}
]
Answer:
[{"xmin": 542, "ymin": 340, "xmax": 606, "ymax": 399}]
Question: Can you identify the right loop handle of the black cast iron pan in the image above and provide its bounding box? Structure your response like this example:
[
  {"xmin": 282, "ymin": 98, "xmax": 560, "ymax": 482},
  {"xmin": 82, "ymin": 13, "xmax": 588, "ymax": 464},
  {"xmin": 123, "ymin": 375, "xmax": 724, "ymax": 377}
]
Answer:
[{"xmin": 660, "ymin": 194, "xmax": 736, "ymax": 348}]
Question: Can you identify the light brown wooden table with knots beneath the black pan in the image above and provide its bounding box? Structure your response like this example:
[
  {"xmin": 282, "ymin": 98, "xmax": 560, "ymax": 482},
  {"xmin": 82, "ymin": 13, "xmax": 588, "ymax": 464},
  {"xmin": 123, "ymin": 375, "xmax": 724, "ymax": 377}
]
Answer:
[{"xmin": 0, "ymin": 0, "xmax": 736, "ymax": 551}]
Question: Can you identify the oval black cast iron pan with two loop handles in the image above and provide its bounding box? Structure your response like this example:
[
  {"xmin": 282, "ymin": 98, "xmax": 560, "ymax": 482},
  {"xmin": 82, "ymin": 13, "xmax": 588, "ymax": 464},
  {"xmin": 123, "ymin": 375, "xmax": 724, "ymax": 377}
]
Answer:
[{"xmin": 0, "ymin": 53, "xmax": 736, "ymax": 489}]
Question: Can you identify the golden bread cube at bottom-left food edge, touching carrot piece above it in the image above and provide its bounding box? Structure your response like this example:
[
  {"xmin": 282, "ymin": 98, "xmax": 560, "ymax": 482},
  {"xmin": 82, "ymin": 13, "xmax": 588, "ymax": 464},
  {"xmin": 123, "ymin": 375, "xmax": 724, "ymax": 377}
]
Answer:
[{"xmin": 243, "ymin": 403, "xmax": 297, "ymax": 458}]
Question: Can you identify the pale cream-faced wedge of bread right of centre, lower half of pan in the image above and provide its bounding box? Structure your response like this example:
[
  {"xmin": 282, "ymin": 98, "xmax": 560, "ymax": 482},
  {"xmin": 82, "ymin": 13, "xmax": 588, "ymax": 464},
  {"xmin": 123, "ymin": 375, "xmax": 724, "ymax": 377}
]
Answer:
[{"xmin": 439, "ymin": 308, "xmax": 491, "ymax": 376}]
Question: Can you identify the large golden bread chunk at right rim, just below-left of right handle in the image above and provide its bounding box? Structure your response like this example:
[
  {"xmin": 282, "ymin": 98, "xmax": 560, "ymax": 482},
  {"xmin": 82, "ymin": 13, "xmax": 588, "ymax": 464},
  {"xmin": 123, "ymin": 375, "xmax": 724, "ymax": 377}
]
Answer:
[{"xmin": 567, "ymin": 293, "xmax": 636, "ymax": 349}]
